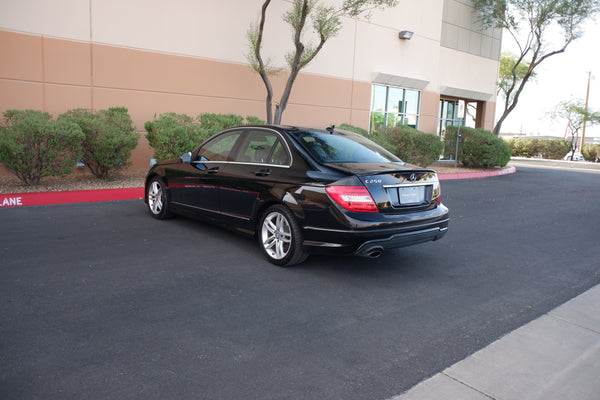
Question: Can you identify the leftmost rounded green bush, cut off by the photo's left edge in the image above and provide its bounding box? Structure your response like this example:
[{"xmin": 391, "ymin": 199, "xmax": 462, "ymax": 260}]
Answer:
[{"xmin": 0, "ymin": 110, "xmax": 84, "ymax": 185}]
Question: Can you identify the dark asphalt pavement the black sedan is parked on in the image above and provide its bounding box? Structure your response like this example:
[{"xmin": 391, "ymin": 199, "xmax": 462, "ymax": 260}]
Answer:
[{"xmin": 0, "ymin": 167, "xmax": 600, "ymax": 399}]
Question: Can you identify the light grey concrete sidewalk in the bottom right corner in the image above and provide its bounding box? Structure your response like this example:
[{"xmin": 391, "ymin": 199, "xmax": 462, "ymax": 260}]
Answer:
[{"xmin": 392, "ymin": 285, "xmax": 600, "ymax": 400}]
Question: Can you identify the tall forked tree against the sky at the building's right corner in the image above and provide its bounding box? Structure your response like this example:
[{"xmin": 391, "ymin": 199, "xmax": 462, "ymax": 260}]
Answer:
[{"xmin": 473, "ymin": 0, "xmax": 600, "ymax": 136}]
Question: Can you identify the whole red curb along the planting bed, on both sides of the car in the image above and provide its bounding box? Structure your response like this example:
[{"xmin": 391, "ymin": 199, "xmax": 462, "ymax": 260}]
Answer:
[{"xmin": 0, "ymin": 167, "xmax": 517, "ymax": 208}]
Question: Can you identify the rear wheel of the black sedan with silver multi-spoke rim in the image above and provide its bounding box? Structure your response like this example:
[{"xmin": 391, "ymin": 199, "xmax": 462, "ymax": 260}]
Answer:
[{"xmin": 258, "ymin": 204, "xmax": 308, "ymax": 267}]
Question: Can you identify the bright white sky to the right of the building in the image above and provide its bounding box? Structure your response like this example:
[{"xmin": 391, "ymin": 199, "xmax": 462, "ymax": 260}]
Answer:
[{"xmin": 496, "ymin": 21, "xmax": 600, "ymax": 140}]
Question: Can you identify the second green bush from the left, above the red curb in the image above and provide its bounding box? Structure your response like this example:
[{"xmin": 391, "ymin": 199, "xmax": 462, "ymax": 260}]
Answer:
[{"xmin": 58, "ymin": 107, "xmax": 140, "ymax": 179}]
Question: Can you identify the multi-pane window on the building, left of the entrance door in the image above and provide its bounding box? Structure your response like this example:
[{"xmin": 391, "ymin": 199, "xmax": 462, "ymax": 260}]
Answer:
[{"xmin": 371, "ymin": 85, "xmax": 421, "ymax": 131}]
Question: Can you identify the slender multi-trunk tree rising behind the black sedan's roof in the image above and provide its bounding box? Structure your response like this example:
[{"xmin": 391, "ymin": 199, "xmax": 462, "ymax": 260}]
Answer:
[{"xmin": 247, "ymin": 0, "xmax": 397, "ymax": 124}]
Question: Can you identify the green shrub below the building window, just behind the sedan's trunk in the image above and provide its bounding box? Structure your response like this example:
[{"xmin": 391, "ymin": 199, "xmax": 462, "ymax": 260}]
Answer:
[{"xmin": 375, "ymin": 125, "xmax": 444, "ymax": 167}]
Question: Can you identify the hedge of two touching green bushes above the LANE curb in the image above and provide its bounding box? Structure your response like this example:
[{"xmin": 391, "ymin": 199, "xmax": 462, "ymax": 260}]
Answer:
[{"xmin": 0, "ymin": 107, "xmax": 139, "ymax": 185}]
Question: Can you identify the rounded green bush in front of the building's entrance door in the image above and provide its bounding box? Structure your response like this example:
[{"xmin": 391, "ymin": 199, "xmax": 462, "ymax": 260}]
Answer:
[{"xmin": 444, "ymin": 126, "xmax": 511, "ymax": 168}]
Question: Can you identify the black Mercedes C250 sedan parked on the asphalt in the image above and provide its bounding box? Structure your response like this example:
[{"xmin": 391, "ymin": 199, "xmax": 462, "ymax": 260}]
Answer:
[{"xmin": 145, "ymin": 126, "xmax": 448, "ymax": 266}]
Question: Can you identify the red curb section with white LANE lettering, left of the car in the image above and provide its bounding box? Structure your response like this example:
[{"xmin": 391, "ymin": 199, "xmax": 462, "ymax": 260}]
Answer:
[{"xmin": 0, "ymin": 187, "xmax": 144, "ymax": 208}]
